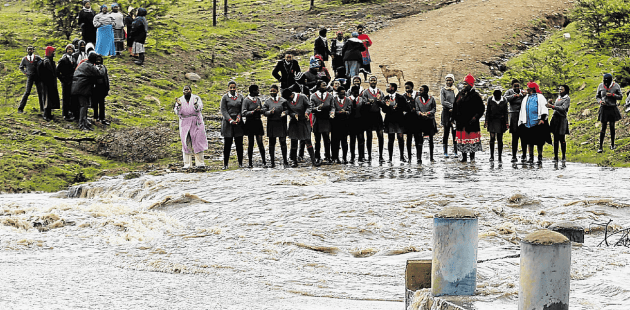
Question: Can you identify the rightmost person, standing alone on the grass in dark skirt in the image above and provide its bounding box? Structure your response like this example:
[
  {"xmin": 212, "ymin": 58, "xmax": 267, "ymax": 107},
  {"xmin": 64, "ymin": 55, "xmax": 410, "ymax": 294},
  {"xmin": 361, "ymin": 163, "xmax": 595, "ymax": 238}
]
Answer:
[{"xmin": 595, "ymin": 73, "xmax": 623, "ymax": 153}]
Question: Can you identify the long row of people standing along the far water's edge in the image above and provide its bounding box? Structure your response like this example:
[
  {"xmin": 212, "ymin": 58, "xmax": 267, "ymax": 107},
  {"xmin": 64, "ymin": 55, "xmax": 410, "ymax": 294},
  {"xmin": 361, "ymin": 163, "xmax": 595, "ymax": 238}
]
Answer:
[{"xmin": 175, "ymin": 63, "xmax": 623, "ymax": 169}]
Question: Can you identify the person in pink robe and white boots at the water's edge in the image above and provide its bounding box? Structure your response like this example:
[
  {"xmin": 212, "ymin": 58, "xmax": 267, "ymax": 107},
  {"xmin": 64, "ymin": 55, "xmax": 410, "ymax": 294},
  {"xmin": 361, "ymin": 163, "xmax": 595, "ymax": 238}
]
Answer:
[{"xmin": 174, "ymin": 86, "xmax": 208, "ymax": 169}]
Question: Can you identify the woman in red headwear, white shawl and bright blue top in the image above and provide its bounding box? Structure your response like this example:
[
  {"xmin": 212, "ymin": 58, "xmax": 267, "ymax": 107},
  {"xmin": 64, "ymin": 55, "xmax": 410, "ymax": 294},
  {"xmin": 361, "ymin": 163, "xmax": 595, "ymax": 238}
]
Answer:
[{"xmin": 518, "ymin": 81, "xmax": 551, "ymax": 165}]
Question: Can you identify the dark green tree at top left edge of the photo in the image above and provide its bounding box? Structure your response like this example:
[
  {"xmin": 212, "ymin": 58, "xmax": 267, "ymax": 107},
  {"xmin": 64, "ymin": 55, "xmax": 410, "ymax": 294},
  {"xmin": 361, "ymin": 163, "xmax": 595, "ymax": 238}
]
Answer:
[{"xmin": 33, "ymin": 0, "xmax": 81, "ymax": 40}]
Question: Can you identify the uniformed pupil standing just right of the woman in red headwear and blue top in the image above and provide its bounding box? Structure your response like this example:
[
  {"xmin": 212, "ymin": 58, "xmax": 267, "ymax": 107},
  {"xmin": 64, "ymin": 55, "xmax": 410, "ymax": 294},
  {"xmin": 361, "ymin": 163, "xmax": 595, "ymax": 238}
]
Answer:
[{"xmin": 547, "ymin": 85, "xmax": 571, "ymax": 162}]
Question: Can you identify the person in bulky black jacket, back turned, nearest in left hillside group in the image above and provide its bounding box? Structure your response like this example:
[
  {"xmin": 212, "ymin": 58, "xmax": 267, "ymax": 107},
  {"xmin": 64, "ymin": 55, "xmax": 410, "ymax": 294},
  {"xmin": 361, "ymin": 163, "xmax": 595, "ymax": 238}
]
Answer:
[{"xmin": 72, "ymin": 52, "xmax": 101, "ymax": 130}]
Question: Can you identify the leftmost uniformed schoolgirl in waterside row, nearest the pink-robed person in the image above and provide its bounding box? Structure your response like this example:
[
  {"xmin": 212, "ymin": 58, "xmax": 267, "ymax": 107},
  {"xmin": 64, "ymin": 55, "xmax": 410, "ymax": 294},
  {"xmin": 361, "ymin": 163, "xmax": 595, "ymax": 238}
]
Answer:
[{"xmin": 220, "ymin": 81, "xmax": 245, "ymax": 169}]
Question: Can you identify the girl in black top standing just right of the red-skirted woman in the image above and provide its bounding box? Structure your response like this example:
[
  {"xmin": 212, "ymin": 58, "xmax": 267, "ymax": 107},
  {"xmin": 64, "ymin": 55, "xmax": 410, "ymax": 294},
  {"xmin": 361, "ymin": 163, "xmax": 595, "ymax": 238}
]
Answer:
[{"xmin": 483, "ymin": 89, "xmax": 510, "ymax": 162}]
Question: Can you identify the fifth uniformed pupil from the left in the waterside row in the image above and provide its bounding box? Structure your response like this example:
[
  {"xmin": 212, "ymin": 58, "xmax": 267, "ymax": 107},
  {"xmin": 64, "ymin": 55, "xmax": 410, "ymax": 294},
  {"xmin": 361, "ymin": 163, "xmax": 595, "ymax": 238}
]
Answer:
[{"xmin": 311, "ymin": 80, "xmax": 341, "ymax": 163}]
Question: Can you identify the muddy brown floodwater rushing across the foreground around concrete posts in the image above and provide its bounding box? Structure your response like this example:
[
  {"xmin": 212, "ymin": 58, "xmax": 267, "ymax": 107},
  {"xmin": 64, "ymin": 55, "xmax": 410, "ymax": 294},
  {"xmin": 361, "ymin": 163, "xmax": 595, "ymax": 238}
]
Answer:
[{"xmin": 0, "ymin": 154, "xmax": 630, "ymax": 309}]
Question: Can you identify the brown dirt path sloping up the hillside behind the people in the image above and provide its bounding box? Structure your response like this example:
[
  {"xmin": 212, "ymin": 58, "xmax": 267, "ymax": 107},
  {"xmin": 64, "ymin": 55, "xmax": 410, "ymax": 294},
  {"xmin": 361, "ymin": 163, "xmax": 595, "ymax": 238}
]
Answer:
[{"xmin": 370, "ymin": 0, "xmax": 572, "ymax": 95}]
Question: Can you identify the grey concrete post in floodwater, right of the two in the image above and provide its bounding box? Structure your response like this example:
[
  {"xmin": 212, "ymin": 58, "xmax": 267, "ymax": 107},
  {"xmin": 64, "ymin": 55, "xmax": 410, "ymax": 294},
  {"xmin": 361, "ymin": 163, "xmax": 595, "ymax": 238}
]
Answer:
[{"xmin": 518, "ymin": 229, "xmax": 571, "ymax": 310}]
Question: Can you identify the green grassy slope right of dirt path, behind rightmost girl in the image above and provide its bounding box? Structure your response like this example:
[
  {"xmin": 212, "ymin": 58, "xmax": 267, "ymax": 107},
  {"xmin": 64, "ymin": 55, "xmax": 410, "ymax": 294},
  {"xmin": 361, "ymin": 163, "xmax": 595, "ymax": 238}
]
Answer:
[{"xmin": 501, "ymin": 23, "xmax": 630, "ymax": 167}]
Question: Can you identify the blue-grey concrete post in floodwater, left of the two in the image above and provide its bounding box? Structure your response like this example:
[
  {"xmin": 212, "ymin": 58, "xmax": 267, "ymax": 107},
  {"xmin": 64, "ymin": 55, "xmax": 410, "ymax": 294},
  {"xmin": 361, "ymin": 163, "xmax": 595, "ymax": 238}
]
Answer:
[{"xmin": 431, "ymin": 208, "xmax": 479, "ymax": 296}]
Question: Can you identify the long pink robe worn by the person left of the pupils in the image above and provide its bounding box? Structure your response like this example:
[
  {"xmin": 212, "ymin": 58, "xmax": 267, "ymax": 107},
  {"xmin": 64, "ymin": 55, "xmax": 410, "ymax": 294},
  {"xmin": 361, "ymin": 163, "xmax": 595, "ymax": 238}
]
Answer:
[{"xmin": 175, "ymin": 95, "xmax": 208, "ymax": 154}]
